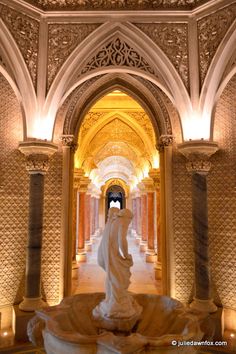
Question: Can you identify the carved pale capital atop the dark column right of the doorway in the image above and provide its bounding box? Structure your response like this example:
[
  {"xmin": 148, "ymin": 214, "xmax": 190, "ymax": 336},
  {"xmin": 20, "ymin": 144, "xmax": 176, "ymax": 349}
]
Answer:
[{"xmin": 178, "ymin": 140, "xmax": 219, "ymax": 174}]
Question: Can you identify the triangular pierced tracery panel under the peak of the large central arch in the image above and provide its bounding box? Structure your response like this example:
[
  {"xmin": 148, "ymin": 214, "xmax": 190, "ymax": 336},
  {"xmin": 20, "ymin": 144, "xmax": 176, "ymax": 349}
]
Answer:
[{"xmin": 81, "ymin": 37, "xmax": 154, "ymax": 74}]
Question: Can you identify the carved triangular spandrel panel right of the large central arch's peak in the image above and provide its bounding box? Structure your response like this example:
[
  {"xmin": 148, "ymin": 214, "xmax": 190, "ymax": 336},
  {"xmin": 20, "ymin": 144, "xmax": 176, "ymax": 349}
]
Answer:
[{"xmin": 135, "ymin": 23, "xmax": 189, "ymax": 88}]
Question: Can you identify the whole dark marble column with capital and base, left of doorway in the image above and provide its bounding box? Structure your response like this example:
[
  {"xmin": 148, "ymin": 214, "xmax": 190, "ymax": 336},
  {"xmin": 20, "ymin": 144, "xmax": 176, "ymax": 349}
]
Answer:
[{"xmin": 19, "ymin": 140, "xmax": 57, "ymax": 311}]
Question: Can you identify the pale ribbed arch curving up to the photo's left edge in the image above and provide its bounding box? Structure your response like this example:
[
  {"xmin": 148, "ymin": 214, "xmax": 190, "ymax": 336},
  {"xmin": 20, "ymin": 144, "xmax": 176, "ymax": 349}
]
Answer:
[{"xmin": 0, "ymin": 19, "xmax": 37, "ymax": 138}]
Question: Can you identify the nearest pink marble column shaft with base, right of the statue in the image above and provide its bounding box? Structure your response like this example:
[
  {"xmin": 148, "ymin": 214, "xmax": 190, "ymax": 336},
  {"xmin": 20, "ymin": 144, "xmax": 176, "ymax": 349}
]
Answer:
[{"xmin": 146, "ymin": 191, "xmax": 156, "ymax": 263}]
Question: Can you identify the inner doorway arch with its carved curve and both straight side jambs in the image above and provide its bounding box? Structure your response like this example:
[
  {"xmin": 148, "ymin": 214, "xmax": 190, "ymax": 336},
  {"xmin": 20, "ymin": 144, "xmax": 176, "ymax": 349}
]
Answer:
[{"xmin": 59, "ymin": 68, "xmax": 175, "ymax": 296}]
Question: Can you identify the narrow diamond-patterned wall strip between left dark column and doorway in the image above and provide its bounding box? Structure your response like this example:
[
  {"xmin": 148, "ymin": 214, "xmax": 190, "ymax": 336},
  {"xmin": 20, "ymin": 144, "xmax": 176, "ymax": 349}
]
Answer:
[{"xmin": 42, "ymin": 151, "xmax": 62, "ymax": 305}]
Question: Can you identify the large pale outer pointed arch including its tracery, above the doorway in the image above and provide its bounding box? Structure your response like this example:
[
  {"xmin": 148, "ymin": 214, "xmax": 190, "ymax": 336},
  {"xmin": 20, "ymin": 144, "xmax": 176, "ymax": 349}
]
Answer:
[{"xmin": 44, "ymin": 22, "xmax": 192, "ymax": 137}]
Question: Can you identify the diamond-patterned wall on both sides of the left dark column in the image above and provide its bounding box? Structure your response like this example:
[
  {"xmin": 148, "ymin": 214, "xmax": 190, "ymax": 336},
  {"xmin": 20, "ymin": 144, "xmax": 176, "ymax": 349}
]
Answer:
[{"xmin": 0, "ymin": 75, "xmax": 62, "ymax": 307}]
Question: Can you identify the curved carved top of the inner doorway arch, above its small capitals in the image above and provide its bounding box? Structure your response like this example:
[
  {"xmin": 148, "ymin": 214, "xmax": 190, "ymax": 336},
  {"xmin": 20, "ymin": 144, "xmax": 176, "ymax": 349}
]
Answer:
[{"xmin": 54, "ymin": 73, "xmax": 182, "ymax": 141}]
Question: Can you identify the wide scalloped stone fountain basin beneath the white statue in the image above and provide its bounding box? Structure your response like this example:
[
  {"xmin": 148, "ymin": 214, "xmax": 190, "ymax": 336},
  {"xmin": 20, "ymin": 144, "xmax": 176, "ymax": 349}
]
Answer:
[{"xmin": 28, "ymin": 293, "xmax": 203, "ymax": 354}]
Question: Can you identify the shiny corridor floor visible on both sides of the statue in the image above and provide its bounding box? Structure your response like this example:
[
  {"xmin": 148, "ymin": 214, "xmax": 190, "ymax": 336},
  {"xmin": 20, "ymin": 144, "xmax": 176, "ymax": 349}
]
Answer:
[{"xmin": 72, "ymin": 237, "xmax": 161, "ymax": 294}]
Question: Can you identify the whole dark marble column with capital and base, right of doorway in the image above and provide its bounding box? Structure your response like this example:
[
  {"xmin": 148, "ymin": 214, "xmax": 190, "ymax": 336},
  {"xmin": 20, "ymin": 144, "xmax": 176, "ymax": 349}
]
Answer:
[{"xmin": 179, "ymin": 141, "xmax": 218, "ymax": 313}]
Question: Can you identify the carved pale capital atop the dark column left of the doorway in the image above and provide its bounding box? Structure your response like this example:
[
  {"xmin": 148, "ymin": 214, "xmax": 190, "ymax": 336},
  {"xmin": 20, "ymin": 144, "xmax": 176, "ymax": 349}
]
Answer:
[{"xmin": 18, "ymin": 140, "xmax": 57, "ymax": 174}]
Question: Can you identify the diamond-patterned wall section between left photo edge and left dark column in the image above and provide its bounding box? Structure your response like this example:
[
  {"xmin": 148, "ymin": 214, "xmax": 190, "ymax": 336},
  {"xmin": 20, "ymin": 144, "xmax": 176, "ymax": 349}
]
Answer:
[{"xmin": 0, "ymin": 74, "xmax": 29, "ymax": 305}]
